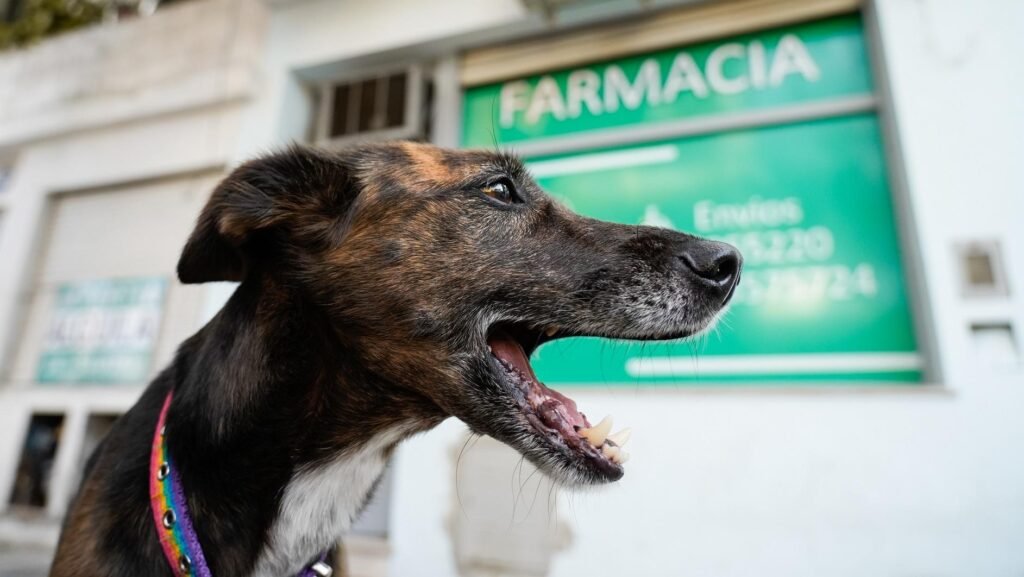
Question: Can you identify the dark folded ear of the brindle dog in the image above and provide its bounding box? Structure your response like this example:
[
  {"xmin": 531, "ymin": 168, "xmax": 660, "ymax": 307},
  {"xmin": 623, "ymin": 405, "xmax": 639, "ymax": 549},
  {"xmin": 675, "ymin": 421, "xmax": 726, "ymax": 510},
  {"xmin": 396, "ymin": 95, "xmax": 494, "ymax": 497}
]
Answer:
[{"xmin": 178, "ymin": 146, "xmax": 350, "ymax": 284}]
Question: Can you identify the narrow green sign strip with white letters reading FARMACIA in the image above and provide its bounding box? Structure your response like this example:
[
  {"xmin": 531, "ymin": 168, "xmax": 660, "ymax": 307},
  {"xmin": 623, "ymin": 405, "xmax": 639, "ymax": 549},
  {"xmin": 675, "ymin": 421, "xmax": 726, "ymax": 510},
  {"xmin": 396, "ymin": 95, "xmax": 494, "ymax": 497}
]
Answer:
[{"xmin": 463, "ymin": 16, "xmax": 871, "ymax": 147}]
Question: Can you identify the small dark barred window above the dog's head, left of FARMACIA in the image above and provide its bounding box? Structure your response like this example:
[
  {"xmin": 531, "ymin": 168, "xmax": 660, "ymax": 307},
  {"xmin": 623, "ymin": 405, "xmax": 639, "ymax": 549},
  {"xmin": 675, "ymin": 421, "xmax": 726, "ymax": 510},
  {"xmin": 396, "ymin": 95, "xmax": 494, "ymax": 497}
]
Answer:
[{"xmin": 315, "ymin": 67, "xmax": 427, "ymax": 145}]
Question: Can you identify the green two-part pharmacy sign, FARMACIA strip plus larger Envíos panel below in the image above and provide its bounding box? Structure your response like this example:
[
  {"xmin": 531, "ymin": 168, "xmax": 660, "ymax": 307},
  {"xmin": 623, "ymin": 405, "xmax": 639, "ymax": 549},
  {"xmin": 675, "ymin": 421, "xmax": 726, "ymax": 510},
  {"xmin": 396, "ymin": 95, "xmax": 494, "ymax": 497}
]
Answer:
[{"xmin": 464, "ymin": 16, "xmax": 922, "ymax": 386}]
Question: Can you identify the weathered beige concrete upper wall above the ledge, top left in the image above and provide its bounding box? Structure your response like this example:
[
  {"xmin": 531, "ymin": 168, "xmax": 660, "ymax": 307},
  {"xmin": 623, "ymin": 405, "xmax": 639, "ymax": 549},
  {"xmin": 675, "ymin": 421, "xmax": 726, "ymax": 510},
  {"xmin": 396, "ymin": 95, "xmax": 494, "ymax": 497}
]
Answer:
[{"xmin": 0, "ymin": 0, "xmax": 265, "ymax": 151}]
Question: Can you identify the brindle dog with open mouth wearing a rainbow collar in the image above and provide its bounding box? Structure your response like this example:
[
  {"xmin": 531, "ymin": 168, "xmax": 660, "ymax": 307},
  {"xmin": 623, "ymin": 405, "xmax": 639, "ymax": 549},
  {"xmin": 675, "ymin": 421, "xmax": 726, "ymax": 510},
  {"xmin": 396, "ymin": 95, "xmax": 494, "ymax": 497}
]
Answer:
[{"xmin": 51, "ymin": 142, "xmax": 741, "ymax": 577}]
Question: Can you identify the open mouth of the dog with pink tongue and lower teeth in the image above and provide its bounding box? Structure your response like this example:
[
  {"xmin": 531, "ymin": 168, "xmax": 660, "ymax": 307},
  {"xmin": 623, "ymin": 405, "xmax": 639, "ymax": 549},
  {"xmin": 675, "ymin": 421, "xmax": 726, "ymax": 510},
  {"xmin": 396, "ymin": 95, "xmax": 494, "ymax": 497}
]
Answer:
[{"xmin": 487, "ymin": 327, "xmax": 630, "ymax": 482}]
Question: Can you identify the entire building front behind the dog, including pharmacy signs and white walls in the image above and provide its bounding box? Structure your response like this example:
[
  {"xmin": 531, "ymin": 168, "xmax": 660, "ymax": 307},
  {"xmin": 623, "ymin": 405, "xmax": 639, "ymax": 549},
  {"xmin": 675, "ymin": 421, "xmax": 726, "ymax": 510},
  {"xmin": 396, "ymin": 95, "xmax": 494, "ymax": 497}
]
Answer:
[{"xmin": 0, "ymin": 0, "xmax": 1024, "ymax": 576}]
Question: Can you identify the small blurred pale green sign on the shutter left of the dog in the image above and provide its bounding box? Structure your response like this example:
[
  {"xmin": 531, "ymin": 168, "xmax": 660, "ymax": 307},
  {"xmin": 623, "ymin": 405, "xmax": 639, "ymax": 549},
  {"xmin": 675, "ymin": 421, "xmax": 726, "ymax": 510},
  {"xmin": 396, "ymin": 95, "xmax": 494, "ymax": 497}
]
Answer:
[{"xmin": 36, "ymin": 278, "xmax": 167, "ymax": 383}]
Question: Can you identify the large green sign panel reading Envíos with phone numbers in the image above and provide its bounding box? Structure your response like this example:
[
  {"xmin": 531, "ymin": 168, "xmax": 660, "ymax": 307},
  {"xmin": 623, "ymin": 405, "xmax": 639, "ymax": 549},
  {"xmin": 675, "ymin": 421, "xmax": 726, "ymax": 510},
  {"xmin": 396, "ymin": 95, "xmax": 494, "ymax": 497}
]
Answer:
[{"xmin": 530, "ymin": 115, "xmax": 921, "ymax": 383}]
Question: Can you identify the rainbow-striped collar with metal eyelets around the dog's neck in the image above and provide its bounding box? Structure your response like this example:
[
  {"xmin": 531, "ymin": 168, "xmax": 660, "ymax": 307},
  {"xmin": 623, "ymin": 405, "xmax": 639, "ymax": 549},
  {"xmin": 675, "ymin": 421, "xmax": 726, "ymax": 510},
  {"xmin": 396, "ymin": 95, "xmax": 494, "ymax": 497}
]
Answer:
[{"xmin": 150, "ymin": 393, "xmax": 332, "ymax": 577}]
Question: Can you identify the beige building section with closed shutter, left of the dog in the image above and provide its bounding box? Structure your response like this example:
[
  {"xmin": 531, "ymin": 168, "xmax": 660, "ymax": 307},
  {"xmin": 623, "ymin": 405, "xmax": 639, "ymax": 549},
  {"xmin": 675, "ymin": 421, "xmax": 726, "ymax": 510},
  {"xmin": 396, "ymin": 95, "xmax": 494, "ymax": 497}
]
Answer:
[{"xmin": 0, "ymin": 0, "xmax": 266, "ymax": 544}]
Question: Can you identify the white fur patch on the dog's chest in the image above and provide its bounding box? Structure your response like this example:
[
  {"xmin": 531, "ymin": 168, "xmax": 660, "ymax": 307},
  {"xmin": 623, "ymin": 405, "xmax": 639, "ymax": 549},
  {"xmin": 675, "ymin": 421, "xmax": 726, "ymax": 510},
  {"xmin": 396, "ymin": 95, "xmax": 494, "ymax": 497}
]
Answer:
[{"xmin": 253, "ymin": 429, "xmax": 403, "ymax": 577}]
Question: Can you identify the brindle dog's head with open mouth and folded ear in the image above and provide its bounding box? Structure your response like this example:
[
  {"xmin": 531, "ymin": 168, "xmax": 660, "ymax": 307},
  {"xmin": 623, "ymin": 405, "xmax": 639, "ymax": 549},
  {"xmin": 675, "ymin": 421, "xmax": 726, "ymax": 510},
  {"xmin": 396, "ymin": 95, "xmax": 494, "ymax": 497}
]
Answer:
[{"xmin": 178, "ymin": 142, "xmax": 741, "ymax": 484}]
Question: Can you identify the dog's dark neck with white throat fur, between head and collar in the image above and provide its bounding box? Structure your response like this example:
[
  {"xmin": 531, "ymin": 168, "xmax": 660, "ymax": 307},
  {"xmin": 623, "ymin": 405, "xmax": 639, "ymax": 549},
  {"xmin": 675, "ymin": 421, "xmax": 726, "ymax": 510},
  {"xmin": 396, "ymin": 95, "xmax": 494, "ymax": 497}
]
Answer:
[{"xmin": 167, "ymin": 276, "xmax": 442, "ymax": 575}]
